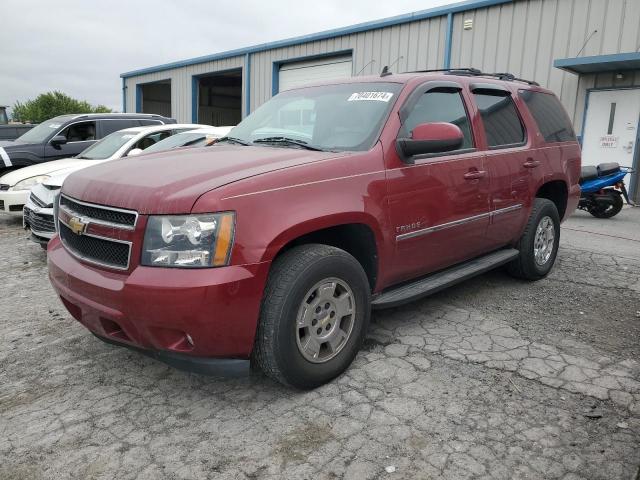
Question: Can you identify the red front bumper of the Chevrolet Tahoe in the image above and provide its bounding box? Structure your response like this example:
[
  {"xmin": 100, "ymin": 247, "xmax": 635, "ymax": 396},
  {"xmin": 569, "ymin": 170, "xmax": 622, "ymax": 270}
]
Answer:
[{"xmin": 47, "ymin": 236, "xmax": 270, "ymax": 374}]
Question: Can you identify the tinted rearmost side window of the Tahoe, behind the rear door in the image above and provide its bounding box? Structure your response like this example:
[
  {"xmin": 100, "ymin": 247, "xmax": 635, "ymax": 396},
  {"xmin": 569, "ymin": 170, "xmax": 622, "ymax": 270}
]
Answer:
[{"xmin": 520, "ymin": 90, "xmax": 576, "ymax": 142}]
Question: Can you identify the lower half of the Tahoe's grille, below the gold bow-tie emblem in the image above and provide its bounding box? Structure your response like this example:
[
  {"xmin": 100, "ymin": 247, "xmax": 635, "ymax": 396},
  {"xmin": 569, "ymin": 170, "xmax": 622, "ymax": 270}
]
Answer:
[{"xmin": 58, "ymin": 222, "xmax": 131, "ymax": 270}]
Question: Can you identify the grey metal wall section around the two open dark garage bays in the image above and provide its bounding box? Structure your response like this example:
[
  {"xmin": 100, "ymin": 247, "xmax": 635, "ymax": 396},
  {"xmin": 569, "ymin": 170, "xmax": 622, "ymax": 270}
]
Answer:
[{"xmin": 125, "ymin": 55, "xmax": 247, "ymax": 123}]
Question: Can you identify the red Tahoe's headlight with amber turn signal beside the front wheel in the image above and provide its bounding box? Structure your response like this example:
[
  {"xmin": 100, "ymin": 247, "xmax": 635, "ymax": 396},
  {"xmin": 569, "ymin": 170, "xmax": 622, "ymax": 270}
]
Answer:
[{"xmin": 141, "ymin": 212, "xmax": 235, "ymax": 268}]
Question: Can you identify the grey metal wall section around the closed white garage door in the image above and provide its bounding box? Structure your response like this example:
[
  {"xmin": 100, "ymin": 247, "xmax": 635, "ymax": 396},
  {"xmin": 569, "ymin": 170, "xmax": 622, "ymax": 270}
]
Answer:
[{"xmin": 251, "ymin": 15, "xmax": 447, "ymax": 110}]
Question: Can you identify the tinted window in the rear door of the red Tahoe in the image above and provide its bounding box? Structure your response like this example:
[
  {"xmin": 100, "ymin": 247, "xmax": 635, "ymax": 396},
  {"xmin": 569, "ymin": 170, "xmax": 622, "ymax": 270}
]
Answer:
[{"xmin": 473, "ymin": 93, "xmax": 525, "ymax": 148}]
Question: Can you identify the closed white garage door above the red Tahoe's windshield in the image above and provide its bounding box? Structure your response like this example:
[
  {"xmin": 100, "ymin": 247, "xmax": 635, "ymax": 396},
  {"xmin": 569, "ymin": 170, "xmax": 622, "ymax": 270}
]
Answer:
[{"xmin": 278, "ymin": 55, "xmax": 352, "ymax": 92}]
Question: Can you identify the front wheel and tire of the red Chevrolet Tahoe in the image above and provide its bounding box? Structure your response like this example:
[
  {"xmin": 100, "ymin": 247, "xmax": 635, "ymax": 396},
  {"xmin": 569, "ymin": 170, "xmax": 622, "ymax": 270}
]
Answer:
[{"xmin": 253, "ymin": 244, "xmax": 371, "ymax": 389}]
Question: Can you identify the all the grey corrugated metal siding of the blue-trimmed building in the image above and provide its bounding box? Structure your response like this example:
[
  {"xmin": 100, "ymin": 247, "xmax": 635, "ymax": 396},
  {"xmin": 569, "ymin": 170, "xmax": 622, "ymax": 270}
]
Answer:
[{"xmin": 126, "ymin": 0, "xmax": 640, "ymax": 132}]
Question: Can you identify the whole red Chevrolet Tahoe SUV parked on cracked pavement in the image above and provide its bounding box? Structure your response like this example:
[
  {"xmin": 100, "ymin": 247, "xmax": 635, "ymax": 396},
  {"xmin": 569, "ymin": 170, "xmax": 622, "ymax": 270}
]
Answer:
[{"xmin": 48, "ymin": 70, "xmax": 580, "ymax": 388}]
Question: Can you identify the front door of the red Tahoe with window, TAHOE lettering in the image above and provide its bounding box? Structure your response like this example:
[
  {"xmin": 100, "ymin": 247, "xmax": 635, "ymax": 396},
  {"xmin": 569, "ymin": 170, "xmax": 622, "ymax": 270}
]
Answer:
[{"xmin": 387, "ymin": 81, "xmax": 489, "ymax": 281}]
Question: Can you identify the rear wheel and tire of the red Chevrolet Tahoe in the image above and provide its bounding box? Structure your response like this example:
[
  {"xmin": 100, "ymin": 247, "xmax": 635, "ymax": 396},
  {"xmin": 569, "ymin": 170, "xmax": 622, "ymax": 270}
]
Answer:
[{"xmin": 507, "ymin": 198, "xmax": 560, "ymax": 280}]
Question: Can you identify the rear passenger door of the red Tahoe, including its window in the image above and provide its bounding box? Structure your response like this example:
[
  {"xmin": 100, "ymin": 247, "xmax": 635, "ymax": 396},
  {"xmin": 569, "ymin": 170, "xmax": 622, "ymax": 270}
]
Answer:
[{"xmin": 470, "ymin": 82, "xmax": 542, "ymax": 249}]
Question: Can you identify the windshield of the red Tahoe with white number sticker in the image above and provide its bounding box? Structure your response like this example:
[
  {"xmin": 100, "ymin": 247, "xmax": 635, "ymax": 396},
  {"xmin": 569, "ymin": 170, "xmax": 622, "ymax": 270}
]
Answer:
[{"xmin": 229, "ymin": 82, "xmax": 402, "ymax": 151}]
